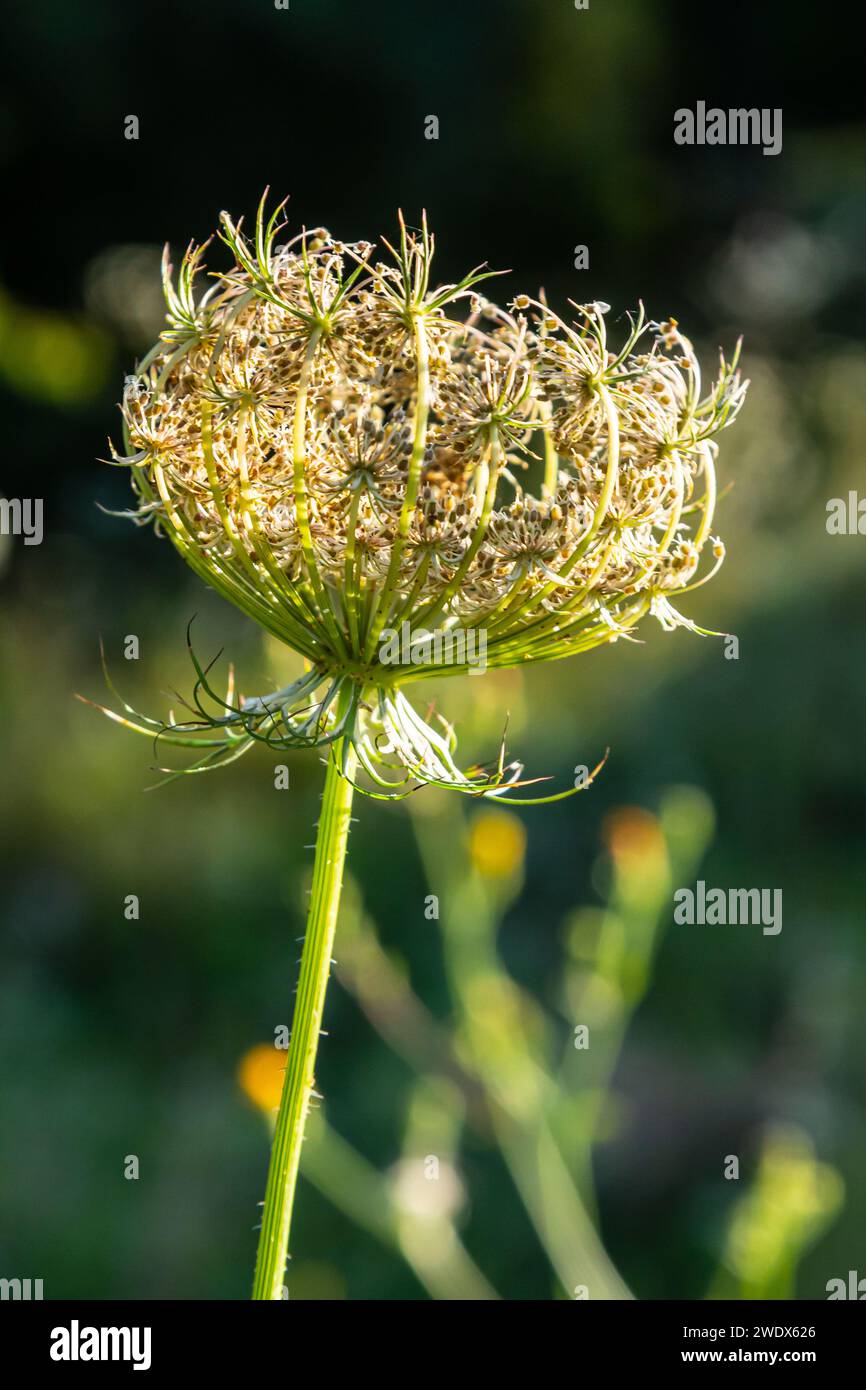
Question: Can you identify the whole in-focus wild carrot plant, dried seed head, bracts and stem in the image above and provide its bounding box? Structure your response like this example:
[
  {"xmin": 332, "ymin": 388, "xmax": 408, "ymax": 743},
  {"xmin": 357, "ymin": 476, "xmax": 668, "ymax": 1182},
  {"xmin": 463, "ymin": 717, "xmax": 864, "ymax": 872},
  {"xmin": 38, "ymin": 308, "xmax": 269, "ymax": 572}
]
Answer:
[{"xmin": 93, "ymin": 197, "xmax": 746, "ymax": 1298}]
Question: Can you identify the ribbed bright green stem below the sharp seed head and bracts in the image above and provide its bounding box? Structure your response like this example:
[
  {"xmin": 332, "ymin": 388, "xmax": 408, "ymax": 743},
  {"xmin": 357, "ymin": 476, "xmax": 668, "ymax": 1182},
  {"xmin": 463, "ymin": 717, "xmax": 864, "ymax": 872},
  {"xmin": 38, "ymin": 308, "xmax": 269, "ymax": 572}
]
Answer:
[{"xmin": 253, "ymin": 744, "xmax": 354, "ymax": 1301}]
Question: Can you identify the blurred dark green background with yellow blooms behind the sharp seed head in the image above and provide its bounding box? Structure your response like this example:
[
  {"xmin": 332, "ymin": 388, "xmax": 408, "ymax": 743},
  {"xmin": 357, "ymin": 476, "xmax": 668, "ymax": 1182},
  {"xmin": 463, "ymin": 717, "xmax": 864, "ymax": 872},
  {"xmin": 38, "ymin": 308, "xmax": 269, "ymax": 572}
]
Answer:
[{"xmin": 0, "ymin": 0, "xmax": 866, "ymax": 1300}]
